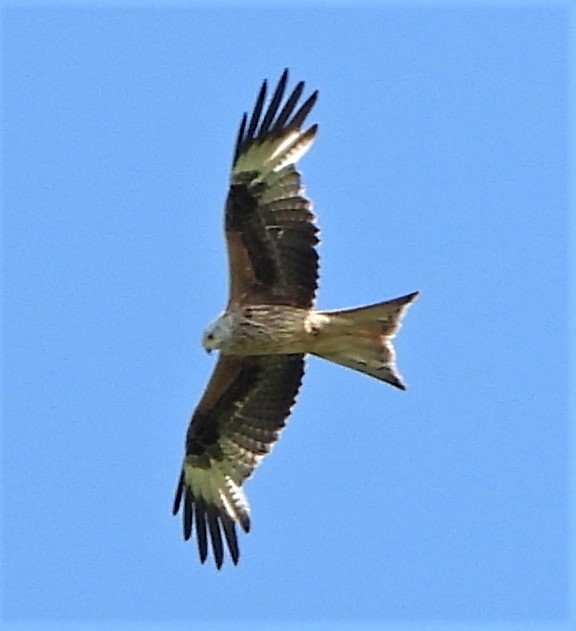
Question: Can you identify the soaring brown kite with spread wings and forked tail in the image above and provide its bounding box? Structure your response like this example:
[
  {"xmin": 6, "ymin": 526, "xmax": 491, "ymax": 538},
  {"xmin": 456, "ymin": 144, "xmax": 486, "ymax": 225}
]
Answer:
[{"xmin": 173, "ymin": 70, "xmax": 418, "ymax": 569}]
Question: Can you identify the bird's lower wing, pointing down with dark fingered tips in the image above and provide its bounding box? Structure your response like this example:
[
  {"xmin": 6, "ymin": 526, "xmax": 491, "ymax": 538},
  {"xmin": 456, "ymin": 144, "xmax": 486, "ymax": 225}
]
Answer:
[{"xmin": 173, "ymin": 354, "xmax": 304, "ymax": 569}]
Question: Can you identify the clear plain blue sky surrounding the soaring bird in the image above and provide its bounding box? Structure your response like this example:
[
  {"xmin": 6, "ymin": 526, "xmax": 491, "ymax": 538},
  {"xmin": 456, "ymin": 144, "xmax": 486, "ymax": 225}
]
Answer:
[{"xmin": 2, "ymin": 2, "xmax": 573, "ymax": 630}]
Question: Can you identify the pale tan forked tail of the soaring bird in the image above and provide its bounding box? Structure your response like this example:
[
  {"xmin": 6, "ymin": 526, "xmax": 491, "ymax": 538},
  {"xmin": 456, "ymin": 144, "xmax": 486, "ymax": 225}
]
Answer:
[{"xmin": 312, "ymin": 291, "xmax": 418, "ymax": 390}]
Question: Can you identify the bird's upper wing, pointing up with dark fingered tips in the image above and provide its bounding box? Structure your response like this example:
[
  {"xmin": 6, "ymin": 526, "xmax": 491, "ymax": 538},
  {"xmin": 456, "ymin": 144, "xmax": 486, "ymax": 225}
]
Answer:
[{"xmin": 226, "ymin": 70, "xmax": 318, "ymax": 308}]
